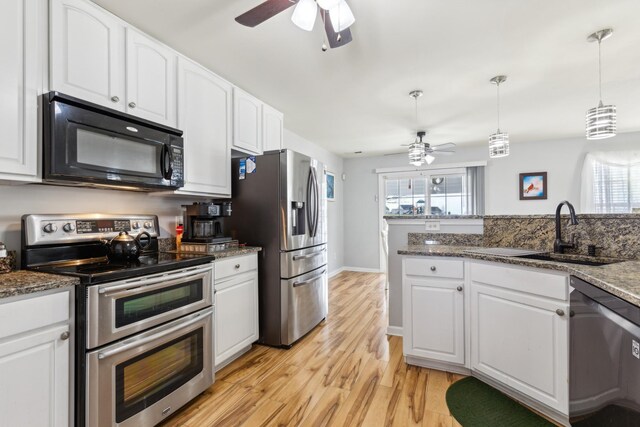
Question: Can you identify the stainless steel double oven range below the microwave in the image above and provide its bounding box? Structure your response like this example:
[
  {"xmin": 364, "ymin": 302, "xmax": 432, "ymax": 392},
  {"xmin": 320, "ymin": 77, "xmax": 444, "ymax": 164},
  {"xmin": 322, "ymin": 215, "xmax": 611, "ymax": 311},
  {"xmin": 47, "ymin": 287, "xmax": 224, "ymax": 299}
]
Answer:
[{"xmin": 22, "ymin": 214, "xmax": 214, "ymax": 427}]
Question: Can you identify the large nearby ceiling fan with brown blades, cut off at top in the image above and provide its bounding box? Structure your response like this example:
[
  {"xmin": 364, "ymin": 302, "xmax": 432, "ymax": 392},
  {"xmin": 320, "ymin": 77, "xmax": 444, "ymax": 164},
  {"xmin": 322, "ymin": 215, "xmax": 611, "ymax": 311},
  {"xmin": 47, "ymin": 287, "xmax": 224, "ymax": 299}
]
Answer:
[{"xmin": 236, "ymin": 0, "xmax": 355, "ymax": 51}]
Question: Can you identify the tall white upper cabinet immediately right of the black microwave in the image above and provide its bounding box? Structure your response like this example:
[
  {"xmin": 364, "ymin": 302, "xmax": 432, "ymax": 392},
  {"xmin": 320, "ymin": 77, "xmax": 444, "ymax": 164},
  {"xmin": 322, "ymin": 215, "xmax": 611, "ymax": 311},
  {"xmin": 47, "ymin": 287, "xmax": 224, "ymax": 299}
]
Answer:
[{"xmin": 178, "ymin": 58, "xmax": 233, "ymax": 197}]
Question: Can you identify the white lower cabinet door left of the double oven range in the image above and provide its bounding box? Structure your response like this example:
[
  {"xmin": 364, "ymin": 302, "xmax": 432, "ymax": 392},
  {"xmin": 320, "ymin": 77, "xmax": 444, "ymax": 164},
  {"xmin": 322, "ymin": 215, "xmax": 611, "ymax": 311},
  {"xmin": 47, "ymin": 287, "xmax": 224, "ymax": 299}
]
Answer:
[{"xmin": 0, "ymin": 325, "xmax": 70, "ymax": 427}]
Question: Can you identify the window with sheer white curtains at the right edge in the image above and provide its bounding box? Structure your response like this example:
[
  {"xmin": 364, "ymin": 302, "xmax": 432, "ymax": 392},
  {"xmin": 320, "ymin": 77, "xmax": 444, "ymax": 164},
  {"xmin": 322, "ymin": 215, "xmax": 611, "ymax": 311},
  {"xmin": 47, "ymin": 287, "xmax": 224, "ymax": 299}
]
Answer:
[{"xmin": 581, "ymin": 151, "xmax": 640, "ymax": 213}]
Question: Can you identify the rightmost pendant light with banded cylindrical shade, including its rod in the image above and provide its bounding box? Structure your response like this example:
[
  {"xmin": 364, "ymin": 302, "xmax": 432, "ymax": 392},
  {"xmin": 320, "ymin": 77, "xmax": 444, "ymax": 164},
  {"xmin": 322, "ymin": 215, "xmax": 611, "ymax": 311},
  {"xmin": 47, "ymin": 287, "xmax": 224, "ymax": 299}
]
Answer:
[{"xmin": 586, "ymin": 28, "xmax": 617, "ymax": 139}]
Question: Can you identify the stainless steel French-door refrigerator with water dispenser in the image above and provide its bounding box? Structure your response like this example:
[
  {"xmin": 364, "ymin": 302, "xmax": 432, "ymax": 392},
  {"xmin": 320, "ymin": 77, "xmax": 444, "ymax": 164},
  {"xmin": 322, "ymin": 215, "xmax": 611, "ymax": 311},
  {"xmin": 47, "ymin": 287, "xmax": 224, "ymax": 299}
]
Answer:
[{"xmin": 228, "ymin": 150, "xmax": 328, "ymax": 347}]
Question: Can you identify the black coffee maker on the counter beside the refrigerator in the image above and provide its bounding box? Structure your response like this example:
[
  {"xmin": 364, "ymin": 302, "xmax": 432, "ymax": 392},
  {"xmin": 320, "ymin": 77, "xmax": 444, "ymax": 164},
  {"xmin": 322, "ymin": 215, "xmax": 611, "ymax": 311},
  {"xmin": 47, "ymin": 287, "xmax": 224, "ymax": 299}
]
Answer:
[{"xmin": 182, "ymin": 201, "xmax": 231, "ymax": 243}]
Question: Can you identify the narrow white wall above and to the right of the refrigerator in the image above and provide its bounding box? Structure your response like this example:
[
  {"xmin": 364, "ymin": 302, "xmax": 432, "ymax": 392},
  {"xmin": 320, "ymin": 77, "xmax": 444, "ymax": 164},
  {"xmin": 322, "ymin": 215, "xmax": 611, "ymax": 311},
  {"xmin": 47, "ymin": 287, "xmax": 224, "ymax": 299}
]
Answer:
[{"xmin": 284, "ymin": 129, "xmax": 345, "ymax": 274}]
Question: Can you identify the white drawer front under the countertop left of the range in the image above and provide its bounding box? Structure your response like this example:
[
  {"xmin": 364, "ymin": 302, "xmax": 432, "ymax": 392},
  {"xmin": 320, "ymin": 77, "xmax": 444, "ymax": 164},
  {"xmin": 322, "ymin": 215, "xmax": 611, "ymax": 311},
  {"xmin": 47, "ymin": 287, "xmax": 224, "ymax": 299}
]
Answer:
[{"xmin": 0, "ymin": 291, "xmax": 71, "ymax": 339}]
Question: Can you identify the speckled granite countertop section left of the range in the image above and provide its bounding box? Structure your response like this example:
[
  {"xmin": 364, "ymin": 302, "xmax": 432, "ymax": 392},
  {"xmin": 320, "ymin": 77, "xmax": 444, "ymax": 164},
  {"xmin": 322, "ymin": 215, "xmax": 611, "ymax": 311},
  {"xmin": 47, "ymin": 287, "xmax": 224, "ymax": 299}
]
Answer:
[{"xmin": 0, "ymin": 270, "xmax": 80, "ymax": 299}]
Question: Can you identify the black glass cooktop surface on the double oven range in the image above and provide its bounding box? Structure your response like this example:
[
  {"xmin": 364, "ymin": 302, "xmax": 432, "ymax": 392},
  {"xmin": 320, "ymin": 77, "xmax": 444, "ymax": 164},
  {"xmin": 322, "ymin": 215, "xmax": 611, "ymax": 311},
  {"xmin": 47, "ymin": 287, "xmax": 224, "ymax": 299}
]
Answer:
[{"xmin": 32, "ymin": 252, "xmax": 214, "ymax": 285}]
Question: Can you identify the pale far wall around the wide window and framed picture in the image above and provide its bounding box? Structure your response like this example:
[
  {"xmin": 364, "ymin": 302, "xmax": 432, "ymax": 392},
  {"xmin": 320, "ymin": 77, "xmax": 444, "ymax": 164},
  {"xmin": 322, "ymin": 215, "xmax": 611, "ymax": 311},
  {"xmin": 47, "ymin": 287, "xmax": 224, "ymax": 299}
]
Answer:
[{"xmin": 344, "ymin": 132, "xmax": 640, "ymax": 269}]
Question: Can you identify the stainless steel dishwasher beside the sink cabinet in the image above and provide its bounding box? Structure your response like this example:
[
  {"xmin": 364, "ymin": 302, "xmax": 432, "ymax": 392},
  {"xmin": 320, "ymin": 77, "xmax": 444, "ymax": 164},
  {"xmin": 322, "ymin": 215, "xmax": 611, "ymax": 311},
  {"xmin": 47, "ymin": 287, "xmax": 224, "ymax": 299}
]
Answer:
[{"xmin": 569, "ymin": 276, "xmax": 640, "ymax": 427}]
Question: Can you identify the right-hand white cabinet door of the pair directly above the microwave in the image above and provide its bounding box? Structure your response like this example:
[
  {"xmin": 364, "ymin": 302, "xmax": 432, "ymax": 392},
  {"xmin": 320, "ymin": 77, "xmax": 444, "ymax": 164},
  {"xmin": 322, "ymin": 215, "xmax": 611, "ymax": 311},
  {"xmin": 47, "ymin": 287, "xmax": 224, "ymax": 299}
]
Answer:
[{"xmin": 126, "ymin": 27, "xmax": 177, "ymax": 127}]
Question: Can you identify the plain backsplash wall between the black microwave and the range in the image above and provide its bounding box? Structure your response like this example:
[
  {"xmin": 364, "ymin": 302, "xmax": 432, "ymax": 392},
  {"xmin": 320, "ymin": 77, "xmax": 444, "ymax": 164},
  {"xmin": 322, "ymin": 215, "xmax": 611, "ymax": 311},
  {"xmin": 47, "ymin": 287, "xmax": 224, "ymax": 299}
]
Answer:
[{"xmin": 0, "ymin": 185, "xmax": 193, "ymax": 266}]
